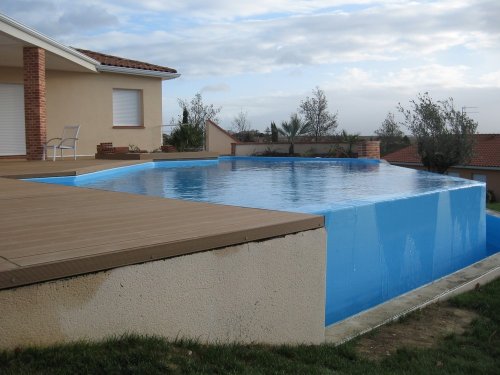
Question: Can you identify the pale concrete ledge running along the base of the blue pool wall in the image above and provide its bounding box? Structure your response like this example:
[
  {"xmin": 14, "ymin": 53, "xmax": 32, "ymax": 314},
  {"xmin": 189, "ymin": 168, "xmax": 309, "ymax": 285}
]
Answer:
[{"xmin": 325, "ymin": 252, "xmax": 500, "ymax": 345}]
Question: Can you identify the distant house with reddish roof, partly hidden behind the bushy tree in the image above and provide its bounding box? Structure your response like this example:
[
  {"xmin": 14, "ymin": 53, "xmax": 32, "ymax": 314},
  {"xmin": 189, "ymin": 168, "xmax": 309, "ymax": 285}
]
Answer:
[{"xmin": 384, "ymin": 134, "xmax": 500, "ymax": 200}]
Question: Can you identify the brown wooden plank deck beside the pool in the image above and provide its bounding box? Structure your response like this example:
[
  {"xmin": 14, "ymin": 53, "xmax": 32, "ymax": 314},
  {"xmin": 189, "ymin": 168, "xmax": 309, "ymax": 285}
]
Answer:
[{"xmin": 0, "ymin": 160, "xmax": 323, "ymax": 289}]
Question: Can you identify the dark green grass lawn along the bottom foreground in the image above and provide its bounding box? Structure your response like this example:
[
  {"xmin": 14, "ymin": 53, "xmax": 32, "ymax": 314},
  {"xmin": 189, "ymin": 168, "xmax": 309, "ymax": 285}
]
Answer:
[{"xmin": 0, "ymin": 279, "xmax": 500, "ymax": 375}]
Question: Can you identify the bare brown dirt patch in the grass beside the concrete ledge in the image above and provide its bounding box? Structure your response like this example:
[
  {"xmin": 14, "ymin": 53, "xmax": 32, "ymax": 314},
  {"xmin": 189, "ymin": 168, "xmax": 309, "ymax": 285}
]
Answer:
[{"xmin": 356, "ymin": 303, "xmax": 478, "ymax": 360}]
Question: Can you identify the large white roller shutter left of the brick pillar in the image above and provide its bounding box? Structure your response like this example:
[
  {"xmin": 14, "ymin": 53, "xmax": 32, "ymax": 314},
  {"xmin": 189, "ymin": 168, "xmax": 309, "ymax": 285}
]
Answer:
[{"xmin": 0, "ymin": 84, "xmax": 26, "ymax": 156}]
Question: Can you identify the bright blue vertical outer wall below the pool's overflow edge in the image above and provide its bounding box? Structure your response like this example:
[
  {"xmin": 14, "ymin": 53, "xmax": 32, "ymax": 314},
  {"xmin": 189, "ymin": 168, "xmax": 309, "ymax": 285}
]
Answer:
[{"xmin": 323, "ymin": 186, "xmax": 487, "ymax": 325}]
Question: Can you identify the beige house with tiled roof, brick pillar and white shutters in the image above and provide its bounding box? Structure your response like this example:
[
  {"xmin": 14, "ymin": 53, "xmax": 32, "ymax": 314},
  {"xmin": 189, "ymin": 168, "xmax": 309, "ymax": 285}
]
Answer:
[{"xmin": 0, "ymin": 14, "xmax": 180, "ymax": 160}]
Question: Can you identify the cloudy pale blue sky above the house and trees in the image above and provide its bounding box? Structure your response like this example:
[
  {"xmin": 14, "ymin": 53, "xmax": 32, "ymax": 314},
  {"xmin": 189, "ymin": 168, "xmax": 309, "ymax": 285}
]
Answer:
[{"xmin": 0, "ymin": 0, "xmax": 500, "ymax": 135}]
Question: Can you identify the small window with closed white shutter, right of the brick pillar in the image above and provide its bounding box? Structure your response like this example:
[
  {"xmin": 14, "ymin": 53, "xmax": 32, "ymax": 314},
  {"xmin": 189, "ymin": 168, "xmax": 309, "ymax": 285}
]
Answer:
[{"xmin": 113, "ymin": 89, "xmax": 144, "ymax": 127}]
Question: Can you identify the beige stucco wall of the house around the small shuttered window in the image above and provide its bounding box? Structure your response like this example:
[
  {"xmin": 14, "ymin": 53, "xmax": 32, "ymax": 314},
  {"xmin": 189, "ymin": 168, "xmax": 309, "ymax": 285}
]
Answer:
[{"xmin": 0, "ymin": 67, "xmax": 162, "ymax": 155}]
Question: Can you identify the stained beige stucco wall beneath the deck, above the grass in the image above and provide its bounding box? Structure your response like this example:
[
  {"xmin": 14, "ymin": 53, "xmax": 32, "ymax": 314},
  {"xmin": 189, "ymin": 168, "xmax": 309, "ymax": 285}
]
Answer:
[{"xmin": 0, "ymin": 228, "xmax": 326, "ymax": 348}]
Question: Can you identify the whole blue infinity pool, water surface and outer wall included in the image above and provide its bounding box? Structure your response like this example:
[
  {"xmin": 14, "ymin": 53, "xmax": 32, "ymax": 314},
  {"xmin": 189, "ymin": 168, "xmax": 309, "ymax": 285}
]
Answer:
[{"xmin": 28, "ymin": 157, "xmax": 488, "ymax": 325}]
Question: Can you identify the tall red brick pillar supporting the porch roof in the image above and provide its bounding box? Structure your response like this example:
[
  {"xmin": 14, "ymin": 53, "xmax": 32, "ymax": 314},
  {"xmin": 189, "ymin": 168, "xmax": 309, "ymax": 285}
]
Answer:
[{"xmin": 23, "ymin": 47, "xmax": 47, "ymax": 160}]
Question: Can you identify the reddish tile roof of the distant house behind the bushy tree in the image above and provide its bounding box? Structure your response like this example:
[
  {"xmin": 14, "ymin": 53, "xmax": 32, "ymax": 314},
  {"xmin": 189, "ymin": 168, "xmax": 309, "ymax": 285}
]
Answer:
[{"xmin": 383, "ymin": 134, "xmax": 500, "ymax": 168}]
